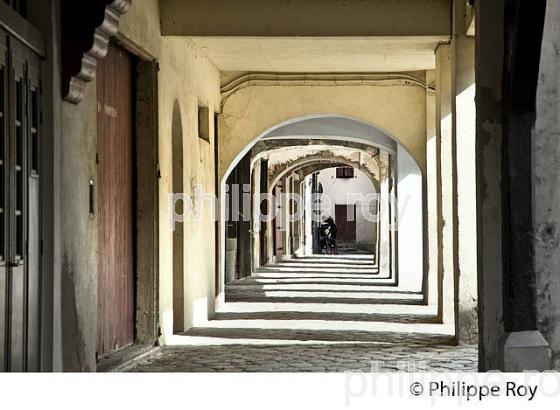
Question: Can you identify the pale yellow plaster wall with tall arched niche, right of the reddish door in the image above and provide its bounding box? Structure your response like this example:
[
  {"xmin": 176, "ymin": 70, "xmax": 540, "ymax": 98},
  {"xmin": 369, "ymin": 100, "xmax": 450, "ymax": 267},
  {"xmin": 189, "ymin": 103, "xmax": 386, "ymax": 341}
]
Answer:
[{"xmin": 159, "ymin": 38, "xmax": 220, "ymax": 344}]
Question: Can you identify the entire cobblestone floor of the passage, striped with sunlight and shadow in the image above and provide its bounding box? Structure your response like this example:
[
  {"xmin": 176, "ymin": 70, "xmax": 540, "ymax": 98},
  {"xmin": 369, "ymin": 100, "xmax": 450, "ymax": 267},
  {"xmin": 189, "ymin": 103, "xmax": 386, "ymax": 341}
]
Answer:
[{"xmin": 133, "ymin": 255, "xmax": 478, "ymax": 372}]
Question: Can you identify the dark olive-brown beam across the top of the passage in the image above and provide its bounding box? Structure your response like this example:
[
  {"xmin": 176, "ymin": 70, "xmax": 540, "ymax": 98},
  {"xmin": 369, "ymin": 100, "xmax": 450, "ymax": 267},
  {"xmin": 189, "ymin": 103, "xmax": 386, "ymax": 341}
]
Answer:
[{"xmin": 161, "ymin": 0, "xmax": 451, "ymax": 37}]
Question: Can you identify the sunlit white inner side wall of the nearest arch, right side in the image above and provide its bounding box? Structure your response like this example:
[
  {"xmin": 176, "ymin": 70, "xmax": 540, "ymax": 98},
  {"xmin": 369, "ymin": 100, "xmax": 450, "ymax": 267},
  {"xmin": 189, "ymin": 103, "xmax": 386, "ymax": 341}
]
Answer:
[{"xmin": 397, "ymin": 145, "xmax": 424, "ymax": 291}]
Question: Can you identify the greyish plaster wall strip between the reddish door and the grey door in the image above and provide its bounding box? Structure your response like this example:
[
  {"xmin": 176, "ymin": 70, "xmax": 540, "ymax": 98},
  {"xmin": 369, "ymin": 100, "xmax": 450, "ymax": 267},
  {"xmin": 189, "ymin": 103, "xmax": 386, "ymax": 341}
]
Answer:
[{"xmin": 61, "ymin": 81, "xmax": 97, "ymax": 371}]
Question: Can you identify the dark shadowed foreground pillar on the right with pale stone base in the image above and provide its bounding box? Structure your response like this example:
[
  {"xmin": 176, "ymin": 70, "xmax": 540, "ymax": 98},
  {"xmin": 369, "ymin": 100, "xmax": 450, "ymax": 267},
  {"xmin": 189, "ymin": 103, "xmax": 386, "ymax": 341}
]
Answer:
[{"xmin": 476, "ymin": 0, "xmax": 551, "ymax": 371}]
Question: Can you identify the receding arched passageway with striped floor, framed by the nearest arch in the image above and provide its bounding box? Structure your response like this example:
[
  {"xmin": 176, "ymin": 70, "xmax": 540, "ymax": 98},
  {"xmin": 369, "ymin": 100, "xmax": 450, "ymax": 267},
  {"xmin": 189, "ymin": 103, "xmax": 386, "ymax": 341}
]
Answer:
[{"xmin": 156, "ymin": 110, "xmax": 455, "ymax": 358}]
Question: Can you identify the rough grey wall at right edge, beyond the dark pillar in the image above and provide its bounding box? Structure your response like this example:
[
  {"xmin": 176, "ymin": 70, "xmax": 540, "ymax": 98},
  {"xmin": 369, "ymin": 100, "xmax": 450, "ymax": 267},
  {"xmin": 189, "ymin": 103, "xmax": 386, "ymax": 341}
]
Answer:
[{"xmin": 534, "ymin": 2, "xmax": 560, "ymax": 368}]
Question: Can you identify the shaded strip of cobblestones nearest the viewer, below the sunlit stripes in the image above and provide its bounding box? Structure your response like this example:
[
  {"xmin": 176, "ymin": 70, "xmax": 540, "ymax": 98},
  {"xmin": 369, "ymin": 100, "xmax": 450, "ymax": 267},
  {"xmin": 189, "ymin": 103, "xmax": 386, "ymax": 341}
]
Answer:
[{"xmin": 133, "ymin": 344, "xmax": 478, "ymax": 373}]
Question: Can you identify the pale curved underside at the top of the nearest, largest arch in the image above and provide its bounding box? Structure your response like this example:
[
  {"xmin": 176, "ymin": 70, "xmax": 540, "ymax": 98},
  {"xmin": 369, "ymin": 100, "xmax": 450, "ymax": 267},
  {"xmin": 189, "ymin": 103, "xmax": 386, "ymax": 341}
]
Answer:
[{"xmin": 221, "ymin": 114, "xmax": 419, "ymax": 186}]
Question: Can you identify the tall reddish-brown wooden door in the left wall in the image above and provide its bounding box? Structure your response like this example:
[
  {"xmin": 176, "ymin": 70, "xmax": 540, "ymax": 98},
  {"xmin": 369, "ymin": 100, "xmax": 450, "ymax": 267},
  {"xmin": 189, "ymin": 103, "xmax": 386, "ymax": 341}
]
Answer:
[{"xmin": 97, "ymin": 40, "xmax": 134, "ymax": 356}]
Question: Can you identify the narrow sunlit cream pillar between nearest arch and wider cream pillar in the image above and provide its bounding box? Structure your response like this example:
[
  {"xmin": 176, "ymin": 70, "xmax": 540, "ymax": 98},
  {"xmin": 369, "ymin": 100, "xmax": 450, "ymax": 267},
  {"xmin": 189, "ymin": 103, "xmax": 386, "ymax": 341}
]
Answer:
[{"xmin": 436, "ymin": 44, "xmax": 457, "ymax": 324}]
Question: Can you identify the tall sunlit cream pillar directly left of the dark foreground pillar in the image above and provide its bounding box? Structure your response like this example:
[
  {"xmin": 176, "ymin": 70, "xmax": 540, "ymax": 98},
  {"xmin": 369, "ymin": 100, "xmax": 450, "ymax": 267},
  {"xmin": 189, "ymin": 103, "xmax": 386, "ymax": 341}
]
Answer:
[{"xmin": 451, "ymin": 1, "xmax": 478, "ymax": 344}]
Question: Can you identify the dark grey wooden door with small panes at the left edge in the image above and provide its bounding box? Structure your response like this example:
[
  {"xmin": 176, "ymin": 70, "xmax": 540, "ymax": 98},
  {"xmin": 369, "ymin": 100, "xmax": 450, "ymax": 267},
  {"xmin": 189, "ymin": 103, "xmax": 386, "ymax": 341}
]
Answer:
[{"xmin": 0, "ymin": 30, "xmax": 41, "ymax": 372}]
